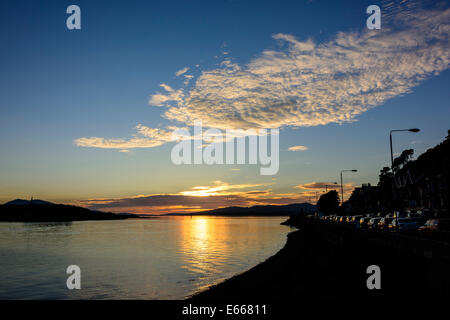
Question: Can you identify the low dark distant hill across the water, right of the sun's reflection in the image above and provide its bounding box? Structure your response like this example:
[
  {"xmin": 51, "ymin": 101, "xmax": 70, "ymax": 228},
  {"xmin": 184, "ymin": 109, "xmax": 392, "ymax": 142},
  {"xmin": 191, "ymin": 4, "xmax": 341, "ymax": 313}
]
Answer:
[{"xmin": 168, "ymin": 203, "xmax": 316, "ymax": 216}]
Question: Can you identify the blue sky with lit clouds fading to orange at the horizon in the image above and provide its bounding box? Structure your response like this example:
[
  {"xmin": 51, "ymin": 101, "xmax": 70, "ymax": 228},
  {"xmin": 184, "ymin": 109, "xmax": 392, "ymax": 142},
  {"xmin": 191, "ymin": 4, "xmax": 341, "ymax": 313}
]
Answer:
[{"xmin": 0, "ymin": 0, "xmax": 450, "ymax": 214}]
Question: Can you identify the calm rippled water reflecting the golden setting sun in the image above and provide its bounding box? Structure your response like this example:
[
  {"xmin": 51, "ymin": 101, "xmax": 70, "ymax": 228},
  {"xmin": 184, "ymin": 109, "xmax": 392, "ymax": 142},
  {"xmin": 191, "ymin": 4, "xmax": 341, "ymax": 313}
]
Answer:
[{"xmin": 0, "ymin": 217, "xmax": 289, "ymax": 299}]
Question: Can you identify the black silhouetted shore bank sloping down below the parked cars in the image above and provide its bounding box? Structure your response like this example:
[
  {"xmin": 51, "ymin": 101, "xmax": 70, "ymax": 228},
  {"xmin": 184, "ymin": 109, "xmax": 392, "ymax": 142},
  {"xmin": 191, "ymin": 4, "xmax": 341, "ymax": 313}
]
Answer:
[{"xmin": 189, "ymin": 216, "xmax": 450, "ymax": 303}]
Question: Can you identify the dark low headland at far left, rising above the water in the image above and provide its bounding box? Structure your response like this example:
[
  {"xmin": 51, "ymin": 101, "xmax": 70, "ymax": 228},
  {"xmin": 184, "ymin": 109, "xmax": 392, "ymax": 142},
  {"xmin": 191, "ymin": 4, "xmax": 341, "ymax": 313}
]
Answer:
[{"xmin": 0, "ymin": 199, "xmax": 139, "ymax": 222}]
